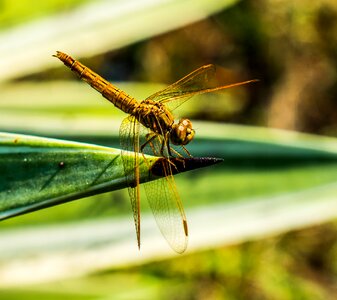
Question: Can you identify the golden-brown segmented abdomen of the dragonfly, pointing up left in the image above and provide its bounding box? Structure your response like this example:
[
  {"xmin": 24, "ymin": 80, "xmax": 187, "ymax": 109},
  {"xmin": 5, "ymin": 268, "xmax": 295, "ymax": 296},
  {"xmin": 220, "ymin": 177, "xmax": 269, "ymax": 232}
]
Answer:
[{"xmin": 55, "ymin": 51, "xmax": 138, "ymax": 114}]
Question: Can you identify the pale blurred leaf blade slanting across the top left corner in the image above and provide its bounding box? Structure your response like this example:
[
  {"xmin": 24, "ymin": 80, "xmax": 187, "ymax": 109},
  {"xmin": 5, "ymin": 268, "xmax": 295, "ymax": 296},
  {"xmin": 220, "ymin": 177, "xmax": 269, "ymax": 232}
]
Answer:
[{"xmin": 0, "ymin": 0, "xmax": 237, "ymax": 81}]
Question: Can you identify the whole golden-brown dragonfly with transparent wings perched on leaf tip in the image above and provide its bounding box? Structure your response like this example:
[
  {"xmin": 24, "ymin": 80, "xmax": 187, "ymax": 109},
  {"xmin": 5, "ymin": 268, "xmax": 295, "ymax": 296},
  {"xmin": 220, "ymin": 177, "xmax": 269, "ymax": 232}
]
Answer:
[{"xmin": 54, "ymin": 51, "xmax": 257, "ymax": 253}]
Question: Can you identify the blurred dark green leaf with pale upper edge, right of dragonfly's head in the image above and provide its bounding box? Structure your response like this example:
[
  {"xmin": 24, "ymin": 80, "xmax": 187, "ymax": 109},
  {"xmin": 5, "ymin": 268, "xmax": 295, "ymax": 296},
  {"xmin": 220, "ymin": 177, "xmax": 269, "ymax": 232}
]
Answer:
[{"xmin": 195, "ymin": 122, "xmax": 337, "ymax": 169}]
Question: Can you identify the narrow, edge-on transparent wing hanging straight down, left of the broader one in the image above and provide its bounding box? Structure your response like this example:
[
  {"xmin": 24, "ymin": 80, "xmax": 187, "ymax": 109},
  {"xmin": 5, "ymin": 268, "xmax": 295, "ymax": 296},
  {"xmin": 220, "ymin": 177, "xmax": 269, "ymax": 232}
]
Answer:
[{"xmin": 119, "ymin": 116, "xmax": 140, "ymax": 248}]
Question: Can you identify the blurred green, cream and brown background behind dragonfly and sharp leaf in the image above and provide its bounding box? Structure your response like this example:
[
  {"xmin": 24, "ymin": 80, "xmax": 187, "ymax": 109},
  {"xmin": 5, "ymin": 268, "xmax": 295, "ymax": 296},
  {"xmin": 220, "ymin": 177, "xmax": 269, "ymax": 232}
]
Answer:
[{"xmin": 0, "ymin": 0, "xmax": 337, "ymax": 299}]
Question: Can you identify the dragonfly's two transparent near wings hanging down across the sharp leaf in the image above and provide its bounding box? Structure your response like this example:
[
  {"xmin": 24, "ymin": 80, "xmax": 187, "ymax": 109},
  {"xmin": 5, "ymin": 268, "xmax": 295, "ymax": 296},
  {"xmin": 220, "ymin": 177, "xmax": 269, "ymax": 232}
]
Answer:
[{"xmin": 120, "ymin": 112, "xmax": 188, "ymax": 253}]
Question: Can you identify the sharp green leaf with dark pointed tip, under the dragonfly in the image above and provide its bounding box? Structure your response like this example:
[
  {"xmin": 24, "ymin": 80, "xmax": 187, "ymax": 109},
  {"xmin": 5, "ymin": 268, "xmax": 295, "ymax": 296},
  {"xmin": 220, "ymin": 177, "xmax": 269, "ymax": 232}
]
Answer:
[{"xmin": 0, "ymin": 133, "xmax": 218, "ymax": 219}]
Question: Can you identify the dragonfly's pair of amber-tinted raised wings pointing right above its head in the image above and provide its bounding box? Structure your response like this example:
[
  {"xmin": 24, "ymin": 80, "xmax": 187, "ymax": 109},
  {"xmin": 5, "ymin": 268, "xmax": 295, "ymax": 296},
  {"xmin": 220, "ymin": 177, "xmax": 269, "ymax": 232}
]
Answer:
[{"xmin": 147, "ymin": 65, "xmax": 256, "ymax": 110}]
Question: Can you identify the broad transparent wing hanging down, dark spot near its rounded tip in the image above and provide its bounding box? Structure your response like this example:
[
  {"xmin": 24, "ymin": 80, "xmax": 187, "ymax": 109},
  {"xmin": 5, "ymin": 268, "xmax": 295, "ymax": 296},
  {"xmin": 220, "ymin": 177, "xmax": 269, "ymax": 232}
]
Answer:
[{"xmin": 144, "ymin": 159, "xmax": 188, "ymax": 253}]
